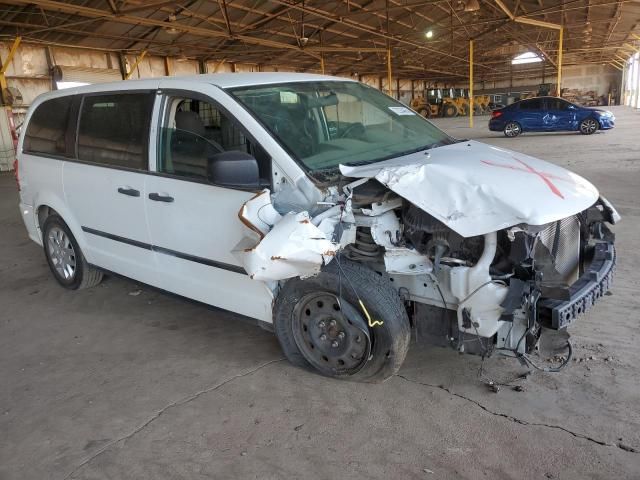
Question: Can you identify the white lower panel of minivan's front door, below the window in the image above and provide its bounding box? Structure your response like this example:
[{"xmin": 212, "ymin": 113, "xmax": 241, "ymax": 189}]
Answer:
[{"xmin": 145, "ymin": 175, "xmax": 273, "ymax": 322}]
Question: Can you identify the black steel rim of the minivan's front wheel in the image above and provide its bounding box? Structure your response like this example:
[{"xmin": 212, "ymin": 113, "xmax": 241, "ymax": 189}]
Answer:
[{"xmin": 292, "ymin": 292, "xmax": 370, "ymax": 375}]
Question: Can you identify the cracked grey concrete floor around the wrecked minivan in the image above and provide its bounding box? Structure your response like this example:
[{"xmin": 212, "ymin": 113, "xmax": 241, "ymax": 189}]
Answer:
[{"xmin": 0, "ymin": 107, "xmax": 640, "ymax": 480}]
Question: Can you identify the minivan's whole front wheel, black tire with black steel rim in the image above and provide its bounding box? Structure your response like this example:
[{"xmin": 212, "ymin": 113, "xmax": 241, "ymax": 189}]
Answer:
[{"xmin": 274, "ymin": 258, "xmax": 411, "ymax": 382}]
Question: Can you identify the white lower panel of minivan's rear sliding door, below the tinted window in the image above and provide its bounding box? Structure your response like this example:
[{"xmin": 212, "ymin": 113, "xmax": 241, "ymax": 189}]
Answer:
[{"xmin": 63, "ymin": 162, "xmax": 156, "ymax": 283}]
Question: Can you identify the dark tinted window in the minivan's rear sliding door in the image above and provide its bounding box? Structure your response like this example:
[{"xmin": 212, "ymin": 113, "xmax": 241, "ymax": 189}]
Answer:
[{"xmin": 78, "ymin": 93, "xmax": 154, "ymax": 170}]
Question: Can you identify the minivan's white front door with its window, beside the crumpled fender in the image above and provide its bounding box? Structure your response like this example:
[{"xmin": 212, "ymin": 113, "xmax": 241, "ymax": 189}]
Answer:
[{"xmin": 145, "ymin": 92, "xmax": 273, "ymax": 322}]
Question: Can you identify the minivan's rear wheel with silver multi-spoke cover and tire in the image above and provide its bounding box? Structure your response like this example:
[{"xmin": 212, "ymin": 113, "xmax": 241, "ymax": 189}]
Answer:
[{"xmin": 42, "ymin": 215, "xmax": 103, "ymax": 290}]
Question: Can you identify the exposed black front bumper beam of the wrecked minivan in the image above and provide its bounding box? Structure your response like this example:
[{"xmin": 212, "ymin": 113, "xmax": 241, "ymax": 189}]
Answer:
[{"xmin": 538, "ymin": 242, "xmax": 616, "ymax": 329}]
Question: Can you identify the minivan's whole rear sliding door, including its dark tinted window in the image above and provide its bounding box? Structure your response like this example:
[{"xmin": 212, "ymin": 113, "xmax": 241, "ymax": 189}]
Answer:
[{"xmin": 63, "ymin": 92, "xmax": 155, "ymax": 283}]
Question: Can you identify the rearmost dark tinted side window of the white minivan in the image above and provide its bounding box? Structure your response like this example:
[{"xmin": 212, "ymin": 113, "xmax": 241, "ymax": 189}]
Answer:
[{"xmin": 22, "ymin": 96, "xmax": 73, "ymax": 156}]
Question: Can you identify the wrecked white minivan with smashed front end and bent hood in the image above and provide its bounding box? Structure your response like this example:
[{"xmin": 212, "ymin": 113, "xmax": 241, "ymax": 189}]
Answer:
[{"xmin": 16, "ymin": 73, "xmax": 619, "ymax": 381}]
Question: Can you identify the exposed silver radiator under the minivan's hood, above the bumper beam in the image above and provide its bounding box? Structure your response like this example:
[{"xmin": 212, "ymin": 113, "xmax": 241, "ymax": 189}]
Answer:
[{"xmin": 540, "ymin": 215, "xmax": 580, "ymax": 285}]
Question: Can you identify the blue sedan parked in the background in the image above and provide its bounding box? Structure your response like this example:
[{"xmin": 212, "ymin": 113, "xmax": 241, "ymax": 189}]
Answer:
[{"xmin": 489, "ymin": 97, "xmax": 615, "ymax": 137}]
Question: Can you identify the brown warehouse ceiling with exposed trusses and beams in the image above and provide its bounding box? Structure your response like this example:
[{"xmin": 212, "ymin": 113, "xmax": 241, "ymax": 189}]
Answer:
[{"xmin": 0, "ymin": 0, "xmax": 640, "ymax": 80}]
